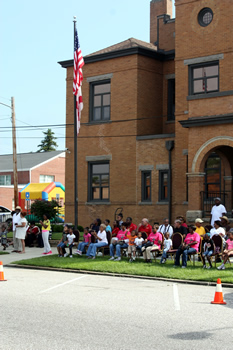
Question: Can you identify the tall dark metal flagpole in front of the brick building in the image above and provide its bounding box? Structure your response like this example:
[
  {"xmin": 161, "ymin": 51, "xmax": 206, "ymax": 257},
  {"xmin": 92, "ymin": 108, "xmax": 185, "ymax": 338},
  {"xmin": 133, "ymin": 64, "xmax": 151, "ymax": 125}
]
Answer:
[{"xmin": 73, "ymin": 16, "xmax": 78, "ymax": 230}]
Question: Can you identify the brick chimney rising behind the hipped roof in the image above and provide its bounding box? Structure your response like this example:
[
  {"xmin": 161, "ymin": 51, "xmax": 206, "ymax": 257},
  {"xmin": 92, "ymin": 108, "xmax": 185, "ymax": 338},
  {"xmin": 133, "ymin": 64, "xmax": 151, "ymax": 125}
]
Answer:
[{"xmin": 150, "ymin": 0, "xmax": 173, "ymax": 44}]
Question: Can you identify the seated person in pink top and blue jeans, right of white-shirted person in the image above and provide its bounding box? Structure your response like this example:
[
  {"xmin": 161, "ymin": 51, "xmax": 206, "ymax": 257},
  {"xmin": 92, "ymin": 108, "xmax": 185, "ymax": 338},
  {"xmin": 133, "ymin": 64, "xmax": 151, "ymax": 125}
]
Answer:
[{"xmin": 109, "ymin": 222, "xmax": 130, "ymax": 261}]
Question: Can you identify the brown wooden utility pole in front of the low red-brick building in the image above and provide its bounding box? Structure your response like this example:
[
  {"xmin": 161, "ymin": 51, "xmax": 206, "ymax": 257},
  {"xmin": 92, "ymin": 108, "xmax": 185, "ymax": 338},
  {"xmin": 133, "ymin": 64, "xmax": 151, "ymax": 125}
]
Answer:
[{"xmin": 11, "ymin": 97, "xmax": 19, "ymax": 208}]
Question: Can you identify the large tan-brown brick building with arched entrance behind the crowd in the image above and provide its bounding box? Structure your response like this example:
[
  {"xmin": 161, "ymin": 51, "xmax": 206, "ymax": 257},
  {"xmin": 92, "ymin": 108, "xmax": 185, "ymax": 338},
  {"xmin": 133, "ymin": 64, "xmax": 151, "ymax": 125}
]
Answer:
[{"xmin": 59, "ymin": 0, "xmax": 233, "ymax": 225}]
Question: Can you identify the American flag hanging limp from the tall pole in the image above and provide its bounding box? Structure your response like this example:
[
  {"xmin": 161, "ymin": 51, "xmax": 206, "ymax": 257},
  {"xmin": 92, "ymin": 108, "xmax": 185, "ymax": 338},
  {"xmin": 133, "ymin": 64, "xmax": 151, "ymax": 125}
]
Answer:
[{"xmin": 73, "ymin": 28, "xmax": 84, "ymax": 135}]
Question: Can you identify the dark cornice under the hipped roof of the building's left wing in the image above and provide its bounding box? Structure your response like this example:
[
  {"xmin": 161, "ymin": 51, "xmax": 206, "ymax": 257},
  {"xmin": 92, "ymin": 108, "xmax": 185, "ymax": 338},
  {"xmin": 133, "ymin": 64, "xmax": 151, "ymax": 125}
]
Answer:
[{"xmin": 58, "ymin": 47, "xmax": 175, "ymax": 68}]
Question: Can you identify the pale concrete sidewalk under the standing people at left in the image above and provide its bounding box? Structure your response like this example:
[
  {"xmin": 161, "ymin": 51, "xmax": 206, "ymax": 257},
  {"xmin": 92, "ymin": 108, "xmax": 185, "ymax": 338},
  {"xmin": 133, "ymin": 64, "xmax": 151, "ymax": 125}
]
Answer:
[{"xmin": 0, "ymin": 247, "xmax": 57, "ymax": 265}]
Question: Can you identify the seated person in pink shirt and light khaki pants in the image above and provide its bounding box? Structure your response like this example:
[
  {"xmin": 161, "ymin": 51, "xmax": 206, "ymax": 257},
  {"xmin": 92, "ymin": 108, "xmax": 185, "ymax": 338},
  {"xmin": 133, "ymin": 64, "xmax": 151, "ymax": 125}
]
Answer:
[{"xmin": 142, "ymin": 225, "xmax": 163, "ymax": 263}]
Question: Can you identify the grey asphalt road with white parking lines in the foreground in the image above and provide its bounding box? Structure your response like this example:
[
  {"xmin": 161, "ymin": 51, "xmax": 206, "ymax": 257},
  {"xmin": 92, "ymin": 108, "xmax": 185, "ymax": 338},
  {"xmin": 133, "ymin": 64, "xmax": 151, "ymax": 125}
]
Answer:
[{"xmin": 0, "ymin": 267, "xmax": 233, "ymax": 350}]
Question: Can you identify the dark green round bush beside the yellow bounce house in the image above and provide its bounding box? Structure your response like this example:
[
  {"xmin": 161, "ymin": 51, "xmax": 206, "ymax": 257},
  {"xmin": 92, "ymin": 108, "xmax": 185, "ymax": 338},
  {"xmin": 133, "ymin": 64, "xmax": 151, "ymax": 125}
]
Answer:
[{"xmin": 31, "ymin": 199, "xmax": 61, "ymax": 220}]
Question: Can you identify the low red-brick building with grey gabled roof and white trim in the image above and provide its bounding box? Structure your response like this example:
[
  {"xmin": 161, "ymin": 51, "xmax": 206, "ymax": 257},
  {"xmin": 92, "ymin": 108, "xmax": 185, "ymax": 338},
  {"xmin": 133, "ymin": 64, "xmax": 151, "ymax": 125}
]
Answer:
[{"xmin": 0, "ymin": 151, "xmax": 66, "ymax": 209}]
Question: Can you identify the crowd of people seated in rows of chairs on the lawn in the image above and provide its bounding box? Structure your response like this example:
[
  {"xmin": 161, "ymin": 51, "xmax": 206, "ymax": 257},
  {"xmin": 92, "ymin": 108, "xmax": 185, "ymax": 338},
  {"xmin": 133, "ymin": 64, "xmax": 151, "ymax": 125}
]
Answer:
[{"xmin": 54, "ymin": 214, "xmax": 233, "ymax": 269}]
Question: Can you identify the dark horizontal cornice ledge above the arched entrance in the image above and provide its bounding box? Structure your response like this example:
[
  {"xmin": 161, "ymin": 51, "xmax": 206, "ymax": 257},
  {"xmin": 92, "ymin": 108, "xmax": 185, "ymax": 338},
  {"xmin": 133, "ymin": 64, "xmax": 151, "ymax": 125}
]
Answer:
[{"xmin": 179, "ymin": 114, "xmax": 233, "ymax": 128}]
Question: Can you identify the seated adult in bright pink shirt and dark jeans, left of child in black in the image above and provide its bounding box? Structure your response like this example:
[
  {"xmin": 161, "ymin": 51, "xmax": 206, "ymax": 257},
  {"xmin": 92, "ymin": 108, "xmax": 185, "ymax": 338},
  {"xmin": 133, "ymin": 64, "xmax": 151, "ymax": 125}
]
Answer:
[{"xmin": 174, "ymin": 225, "xmax": 201, "ymax": 268}]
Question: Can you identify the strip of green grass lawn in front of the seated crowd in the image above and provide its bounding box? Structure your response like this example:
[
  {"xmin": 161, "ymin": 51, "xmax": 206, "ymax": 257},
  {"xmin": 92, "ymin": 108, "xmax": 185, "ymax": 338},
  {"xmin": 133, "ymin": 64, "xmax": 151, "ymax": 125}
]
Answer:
[{"xmin": 11, "ymin": 254, "xmax": 233, "ymax": 283}]
